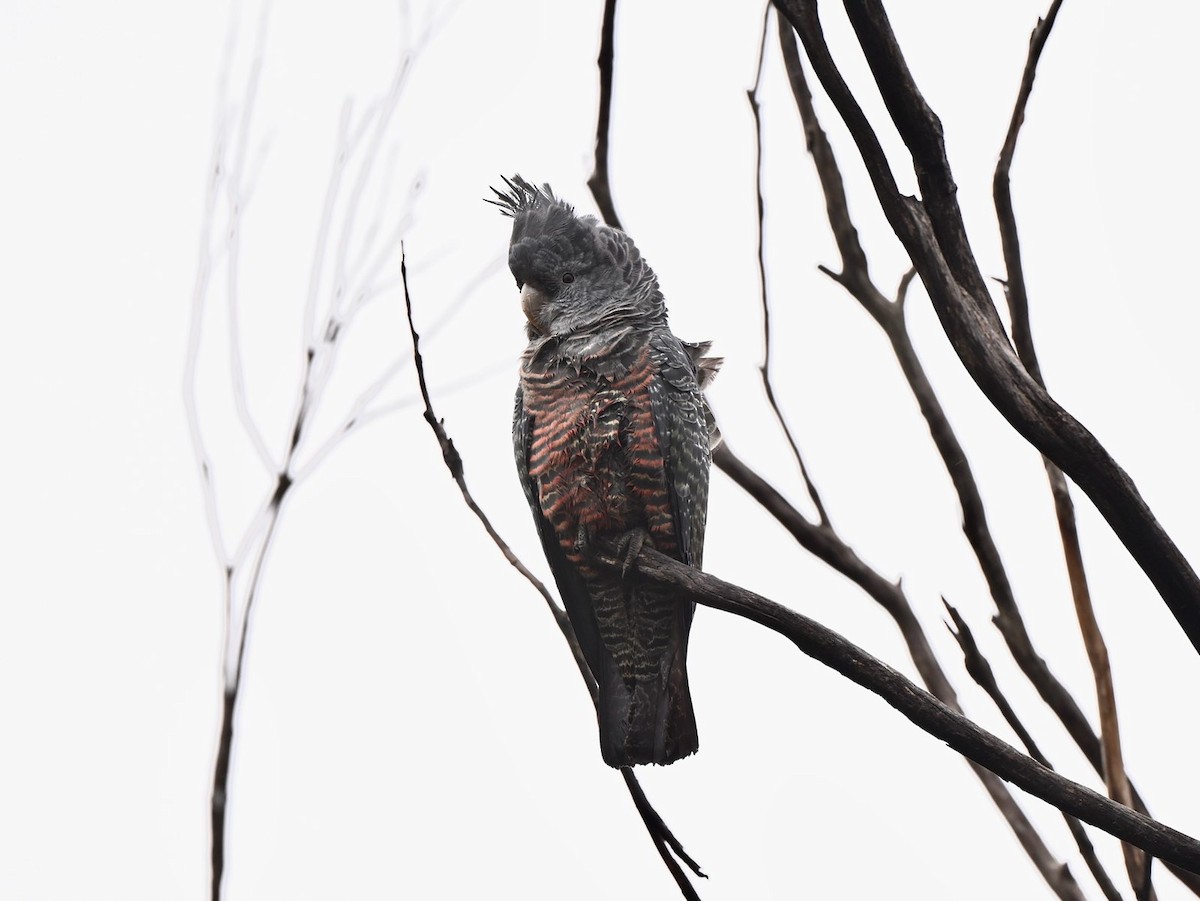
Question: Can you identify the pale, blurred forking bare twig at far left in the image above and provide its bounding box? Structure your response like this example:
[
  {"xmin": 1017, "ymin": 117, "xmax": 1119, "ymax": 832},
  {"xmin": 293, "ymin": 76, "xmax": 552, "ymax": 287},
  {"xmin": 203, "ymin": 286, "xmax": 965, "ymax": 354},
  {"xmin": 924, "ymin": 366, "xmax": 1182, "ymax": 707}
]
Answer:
[{"xmin": 192, "ymin": 16, "xmax": 451, "ymax": 901}]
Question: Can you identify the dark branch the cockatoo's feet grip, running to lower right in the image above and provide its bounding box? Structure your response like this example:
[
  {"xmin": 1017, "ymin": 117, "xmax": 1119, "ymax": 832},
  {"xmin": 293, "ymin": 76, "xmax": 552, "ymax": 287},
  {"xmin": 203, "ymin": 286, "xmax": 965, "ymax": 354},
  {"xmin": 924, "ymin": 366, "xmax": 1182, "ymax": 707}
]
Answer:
[{"xmin": 596, "ymin": 542, "xmax": 1200, "ymax": 871}]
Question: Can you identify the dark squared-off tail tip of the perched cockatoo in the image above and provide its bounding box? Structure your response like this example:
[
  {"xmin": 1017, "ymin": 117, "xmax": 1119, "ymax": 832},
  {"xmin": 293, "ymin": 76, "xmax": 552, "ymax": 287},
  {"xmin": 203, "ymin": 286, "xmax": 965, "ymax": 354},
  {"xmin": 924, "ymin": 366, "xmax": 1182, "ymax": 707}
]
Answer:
[{"xmin": 599, "ymin": 645, "xmax": 700, "ymax": 767}]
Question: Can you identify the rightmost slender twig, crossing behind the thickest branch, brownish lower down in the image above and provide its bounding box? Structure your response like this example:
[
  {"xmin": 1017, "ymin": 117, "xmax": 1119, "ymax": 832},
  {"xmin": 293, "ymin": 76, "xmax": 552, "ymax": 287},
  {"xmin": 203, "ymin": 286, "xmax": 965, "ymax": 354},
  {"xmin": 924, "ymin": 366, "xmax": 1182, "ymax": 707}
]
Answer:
[{"xmin": 992, "ymin": 8, "xmax": 1153, "ymax": 901}]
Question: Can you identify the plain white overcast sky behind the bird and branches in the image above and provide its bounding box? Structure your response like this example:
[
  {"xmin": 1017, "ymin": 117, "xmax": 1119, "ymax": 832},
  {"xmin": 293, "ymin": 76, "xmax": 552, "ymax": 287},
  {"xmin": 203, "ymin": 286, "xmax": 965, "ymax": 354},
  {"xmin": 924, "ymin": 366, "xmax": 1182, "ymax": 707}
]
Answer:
[{"xmin": 0, "ymin": 0, "xmax": 1200, "ymax": 901}]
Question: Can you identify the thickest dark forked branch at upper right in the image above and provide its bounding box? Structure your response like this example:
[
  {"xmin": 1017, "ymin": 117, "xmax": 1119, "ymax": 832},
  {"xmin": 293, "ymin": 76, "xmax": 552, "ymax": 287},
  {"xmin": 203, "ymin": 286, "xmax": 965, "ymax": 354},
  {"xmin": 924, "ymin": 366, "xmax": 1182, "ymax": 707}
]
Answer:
[{"xmin": 776, "ymin": 0, "xmax": 1200, "ymax": 650}]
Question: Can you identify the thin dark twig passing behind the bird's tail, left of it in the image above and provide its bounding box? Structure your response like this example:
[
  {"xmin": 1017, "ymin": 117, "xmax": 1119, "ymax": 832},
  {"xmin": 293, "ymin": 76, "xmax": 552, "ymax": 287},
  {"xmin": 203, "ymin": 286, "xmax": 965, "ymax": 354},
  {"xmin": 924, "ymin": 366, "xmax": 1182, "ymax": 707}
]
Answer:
[{"xmin": 400, "ymin": 245, "xmax": 707, "ymax": 901}]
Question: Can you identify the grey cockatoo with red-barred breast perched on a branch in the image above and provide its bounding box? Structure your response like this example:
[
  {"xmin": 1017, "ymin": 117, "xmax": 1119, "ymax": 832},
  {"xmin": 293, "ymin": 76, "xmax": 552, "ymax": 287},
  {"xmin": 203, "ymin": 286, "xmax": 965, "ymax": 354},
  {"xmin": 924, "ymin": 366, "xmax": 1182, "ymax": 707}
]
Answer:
[{"xmin": 492, "ymin": 176, "xmax": 720, "ymax": 767}]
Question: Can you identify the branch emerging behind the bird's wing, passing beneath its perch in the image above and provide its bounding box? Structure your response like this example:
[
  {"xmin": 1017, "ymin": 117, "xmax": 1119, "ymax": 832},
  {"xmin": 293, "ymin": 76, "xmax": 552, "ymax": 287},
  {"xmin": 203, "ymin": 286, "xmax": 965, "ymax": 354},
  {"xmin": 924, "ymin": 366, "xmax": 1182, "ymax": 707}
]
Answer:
[{"xmin": 713, "ymin": 444, "xmax": 1082, "ymax": 899}]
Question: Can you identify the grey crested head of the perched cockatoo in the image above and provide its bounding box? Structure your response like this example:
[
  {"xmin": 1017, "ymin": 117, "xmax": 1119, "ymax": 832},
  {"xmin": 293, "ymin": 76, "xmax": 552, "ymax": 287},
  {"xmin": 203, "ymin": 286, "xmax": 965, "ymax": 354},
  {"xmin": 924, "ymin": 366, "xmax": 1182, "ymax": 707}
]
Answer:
[{"xmin": 490, "ymin": 175, "xmax": 661, "ymax": 337}]
